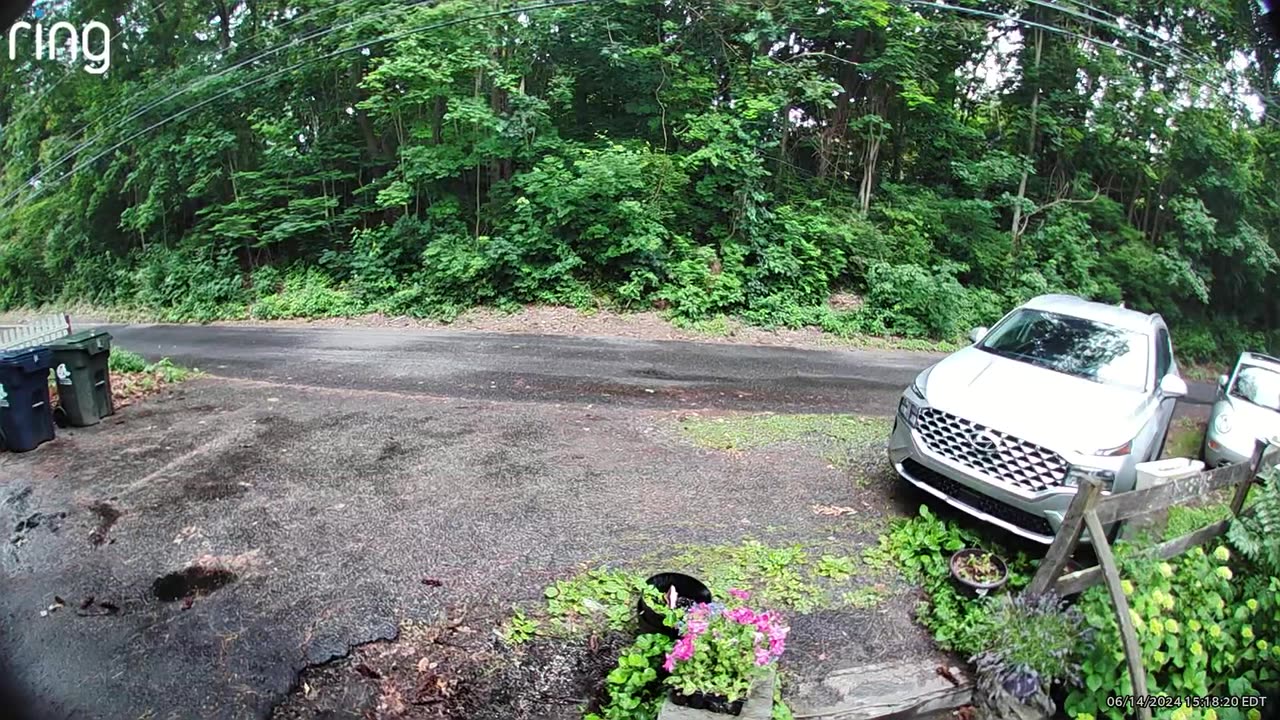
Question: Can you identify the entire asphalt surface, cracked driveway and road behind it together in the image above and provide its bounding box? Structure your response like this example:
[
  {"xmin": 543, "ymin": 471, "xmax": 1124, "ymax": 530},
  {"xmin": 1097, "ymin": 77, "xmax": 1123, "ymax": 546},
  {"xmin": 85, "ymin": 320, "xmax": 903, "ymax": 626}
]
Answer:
[{"xmin": 0, "ymin": 325, "xmax": 1213, "ymax": 717}]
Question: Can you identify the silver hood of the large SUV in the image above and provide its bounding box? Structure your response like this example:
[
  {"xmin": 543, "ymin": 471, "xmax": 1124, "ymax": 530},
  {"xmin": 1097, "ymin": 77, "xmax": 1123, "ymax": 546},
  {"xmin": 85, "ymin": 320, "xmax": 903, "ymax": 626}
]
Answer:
[{"xmin": 920, "ymin": 347, "xmax": 1147, "ymax": 452}]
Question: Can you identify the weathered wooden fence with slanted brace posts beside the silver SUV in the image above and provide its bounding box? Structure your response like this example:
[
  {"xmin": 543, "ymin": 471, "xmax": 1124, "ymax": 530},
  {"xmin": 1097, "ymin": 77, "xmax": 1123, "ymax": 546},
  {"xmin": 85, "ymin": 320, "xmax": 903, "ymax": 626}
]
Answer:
[{"xmin": 1025, "ymin": 441, "xmax": 1280, "ymax": 720}]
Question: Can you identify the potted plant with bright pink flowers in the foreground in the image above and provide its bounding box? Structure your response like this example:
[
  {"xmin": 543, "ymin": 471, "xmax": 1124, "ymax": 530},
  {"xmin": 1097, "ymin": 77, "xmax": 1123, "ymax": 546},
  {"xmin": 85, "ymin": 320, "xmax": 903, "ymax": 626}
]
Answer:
[{"xmin": 663, "ymin": 589, "xmax": 788, "ymax": 717}]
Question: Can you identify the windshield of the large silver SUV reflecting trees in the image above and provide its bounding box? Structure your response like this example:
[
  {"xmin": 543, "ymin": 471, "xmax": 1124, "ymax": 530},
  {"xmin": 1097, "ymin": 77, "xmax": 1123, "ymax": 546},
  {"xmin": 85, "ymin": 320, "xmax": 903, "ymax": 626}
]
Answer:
[{"xmin": 978, "ymin": 309, "xmax": 1151, "ymax": 391}]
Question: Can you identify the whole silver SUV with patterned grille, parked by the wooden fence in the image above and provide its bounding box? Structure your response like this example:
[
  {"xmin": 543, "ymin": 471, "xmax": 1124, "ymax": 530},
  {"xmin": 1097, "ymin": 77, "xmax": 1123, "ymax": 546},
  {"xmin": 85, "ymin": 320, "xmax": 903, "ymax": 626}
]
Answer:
[{"xmin": 888, "ymin": 295, "xmax": 1187, "ymax": 543}]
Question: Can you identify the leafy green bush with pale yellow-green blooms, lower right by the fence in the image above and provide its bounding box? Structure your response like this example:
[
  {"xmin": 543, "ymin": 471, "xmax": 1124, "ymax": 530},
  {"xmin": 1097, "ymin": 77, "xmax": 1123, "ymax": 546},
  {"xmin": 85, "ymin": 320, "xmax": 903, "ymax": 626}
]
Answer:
[{"xmin": 1065, "ymin": 546, "xmax": 1280, "ymax": 720}]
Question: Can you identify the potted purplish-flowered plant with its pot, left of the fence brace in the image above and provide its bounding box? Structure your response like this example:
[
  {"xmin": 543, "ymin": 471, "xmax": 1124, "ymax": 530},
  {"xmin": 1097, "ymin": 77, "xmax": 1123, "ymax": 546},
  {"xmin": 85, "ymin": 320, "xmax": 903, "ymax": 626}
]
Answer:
[{"xmin": 970, "ymin": 593, "xmax": 1092, "ymax": 720}]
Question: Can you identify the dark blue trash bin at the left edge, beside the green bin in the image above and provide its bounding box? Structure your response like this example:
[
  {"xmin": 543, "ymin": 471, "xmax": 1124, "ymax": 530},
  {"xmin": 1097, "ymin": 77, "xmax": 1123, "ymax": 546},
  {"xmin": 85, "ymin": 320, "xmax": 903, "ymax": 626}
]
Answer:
[{"xmin": 0, "ymin": 347, "xmax": 54, "ymax": 452}]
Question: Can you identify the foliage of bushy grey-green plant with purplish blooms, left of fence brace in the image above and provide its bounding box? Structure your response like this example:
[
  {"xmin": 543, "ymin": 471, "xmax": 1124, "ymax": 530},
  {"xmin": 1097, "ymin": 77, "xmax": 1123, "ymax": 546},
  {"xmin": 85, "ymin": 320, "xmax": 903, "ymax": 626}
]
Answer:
[{"xmin": 970, "ymin": 593, "xmax": 1092, "ymax": 700}]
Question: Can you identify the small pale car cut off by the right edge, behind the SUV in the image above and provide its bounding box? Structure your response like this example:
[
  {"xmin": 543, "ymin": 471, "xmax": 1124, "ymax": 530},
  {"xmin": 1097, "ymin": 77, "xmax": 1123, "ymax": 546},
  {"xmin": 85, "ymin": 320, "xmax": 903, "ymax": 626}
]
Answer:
[{"xmin": 1203, "ymin": 352, "xmax": 1280, "ymax": 468}]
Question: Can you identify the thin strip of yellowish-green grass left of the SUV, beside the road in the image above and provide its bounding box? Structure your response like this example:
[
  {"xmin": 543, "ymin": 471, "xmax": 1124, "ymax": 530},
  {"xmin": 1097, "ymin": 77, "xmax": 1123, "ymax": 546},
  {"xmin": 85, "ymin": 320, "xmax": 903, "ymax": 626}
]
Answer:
[{"xmin": 680, "ymin": 414, "xmax": 891, "ymax": 450}]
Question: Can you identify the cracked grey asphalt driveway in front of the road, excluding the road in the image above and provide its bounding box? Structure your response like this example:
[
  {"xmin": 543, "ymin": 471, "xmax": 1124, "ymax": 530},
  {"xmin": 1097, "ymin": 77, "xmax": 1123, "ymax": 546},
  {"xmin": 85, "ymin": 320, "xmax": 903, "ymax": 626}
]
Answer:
[{"xmin": 0, "ymin": 379, "xmax": 911, "ymax": 717}]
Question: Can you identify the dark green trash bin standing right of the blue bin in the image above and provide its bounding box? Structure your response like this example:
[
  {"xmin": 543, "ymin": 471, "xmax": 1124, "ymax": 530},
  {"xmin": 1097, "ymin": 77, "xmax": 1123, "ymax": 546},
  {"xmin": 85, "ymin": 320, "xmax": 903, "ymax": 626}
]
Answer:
[{"xmin": 49, "ymin": 331, "xmax": 115, "ymax": 428}]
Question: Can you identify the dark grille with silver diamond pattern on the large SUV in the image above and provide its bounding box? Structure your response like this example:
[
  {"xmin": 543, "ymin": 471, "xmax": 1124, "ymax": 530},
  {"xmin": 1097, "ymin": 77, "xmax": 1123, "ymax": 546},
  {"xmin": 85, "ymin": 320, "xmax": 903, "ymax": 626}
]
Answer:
[{"xmin": 916, "ymin": 407, "xmax": 1068, "ymax": 492}]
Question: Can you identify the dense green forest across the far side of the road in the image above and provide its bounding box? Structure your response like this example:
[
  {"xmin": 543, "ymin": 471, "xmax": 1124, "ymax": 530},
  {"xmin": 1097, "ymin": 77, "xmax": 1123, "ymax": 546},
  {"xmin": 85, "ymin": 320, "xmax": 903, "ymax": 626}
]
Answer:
[{"xmin": 0, "ymin": 0, "xmax": 1280, "ymax": 359}]
